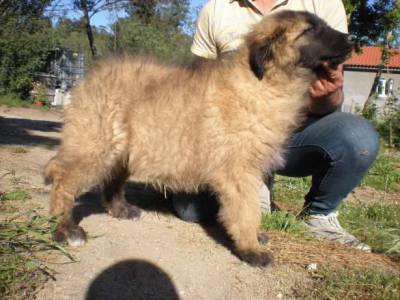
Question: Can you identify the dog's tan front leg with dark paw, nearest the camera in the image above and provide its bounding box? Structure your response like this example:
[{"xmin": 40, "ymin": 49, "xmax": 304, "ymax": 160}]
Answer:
[{"xmin": 212, "ymin": 171, "xmax": 273, "ymax": 266}]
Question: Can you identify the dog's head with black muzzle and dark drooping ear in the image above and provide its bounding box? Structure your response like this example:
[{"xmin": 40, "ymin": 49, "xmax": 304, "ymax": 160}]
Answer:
[{"xmin": 247, "ymin": 11, "xmax": 355, "ymax": 80}]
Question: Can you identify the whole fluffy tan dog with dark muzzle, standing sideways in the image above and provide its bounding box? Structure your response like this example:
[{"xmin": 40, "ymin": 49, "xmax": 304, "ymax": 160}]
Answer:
[{"xmin": 45, "ymin": 11, "xmax": 353, "ymax": 266}]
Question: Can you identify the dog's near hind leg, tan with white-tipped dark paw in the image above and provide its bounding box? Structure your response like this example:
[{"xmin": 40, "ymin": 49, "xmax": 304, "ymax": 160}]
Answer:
[{"xmin": 46, "ymin": 155, "xmax": 111, "ymax": 246}]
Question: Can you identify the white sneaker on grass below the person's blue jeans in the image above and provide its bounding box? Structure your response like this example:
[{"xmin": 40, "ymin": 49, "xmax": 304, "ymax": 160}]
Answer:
[{"xmin": 303, "ymin": 212, "xmax": 371, "ymax": 252}]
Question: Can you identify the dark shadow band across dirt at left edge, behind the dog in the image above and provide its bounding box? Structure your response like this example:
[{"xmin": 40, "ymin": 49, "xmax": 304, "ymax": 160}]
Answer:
[{"xmin": 0, "ymin": 116, "xmax": 62, "ymax": 149}]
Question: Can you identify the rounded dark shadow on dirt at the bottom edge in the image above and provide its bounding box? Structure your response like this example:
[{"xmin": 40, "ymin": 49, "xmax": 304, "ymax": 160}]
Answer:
[{"xmin": 85, "ymin": 260, "xmax": 179, "ymax": 300}]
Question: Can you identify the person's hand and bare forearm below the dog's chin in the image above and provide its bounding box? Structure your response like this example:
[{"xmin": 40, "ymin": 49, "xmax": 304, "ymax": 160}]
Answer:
[{"xmin": 309, "ymin": 64, "xmax": 344, "ymax": 115}]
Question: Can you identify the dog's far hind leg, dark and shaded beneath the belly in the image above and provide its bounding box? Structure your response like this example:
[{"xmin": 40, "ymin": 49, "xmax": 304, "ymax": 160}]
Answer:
[{"xmin": 103, "ymin": 165, "xmax": 141, "ymax": 219}]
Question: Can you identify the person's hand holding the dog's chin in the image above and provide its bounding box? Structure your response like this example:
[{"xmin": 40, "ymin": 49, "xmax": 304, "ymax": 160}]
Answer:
[{"xmin": 309, "ymin": 62, "xmax": 343, "ymax": 98}]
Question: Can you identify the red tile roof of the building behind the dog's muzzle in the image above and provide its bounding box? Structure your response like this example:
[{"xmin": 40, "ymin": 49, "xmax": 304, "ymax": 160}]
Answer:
[{"xmin": 345, "ymin": 47, "xmax": 400, "ymax": 69}]
